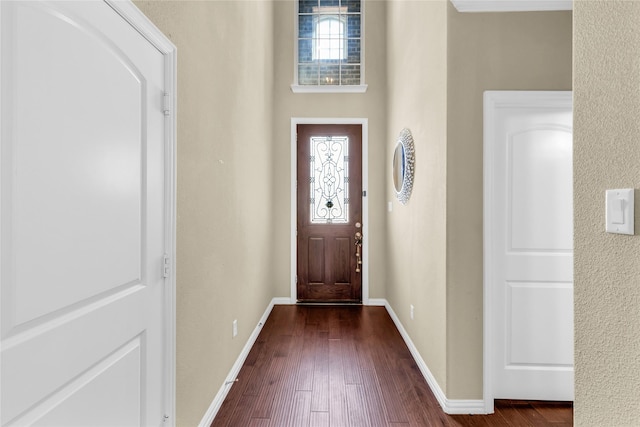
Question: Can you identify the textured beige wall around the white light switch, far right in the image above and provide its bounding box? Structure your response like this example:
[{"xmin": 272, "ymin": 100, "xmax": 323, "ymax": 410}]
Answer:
[{"xmin": 573, "ymin": 1, "xmax": 640, "ymax": 427}]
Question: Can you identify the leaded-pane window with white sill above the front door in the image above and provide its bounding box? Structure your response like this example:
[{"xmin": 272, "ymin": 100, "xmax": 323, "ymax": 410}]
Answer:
[{"xmin": 291, "ymin": 0, "xmax": 367, "ymax": 93}]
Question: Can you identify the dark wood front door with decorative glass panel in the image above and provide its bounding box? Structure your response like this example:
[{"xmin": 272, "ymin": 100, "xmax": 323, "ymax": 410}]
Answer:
[{"xmin": 297, "ymin": 125, "xmax": 366, "ymax": 303}]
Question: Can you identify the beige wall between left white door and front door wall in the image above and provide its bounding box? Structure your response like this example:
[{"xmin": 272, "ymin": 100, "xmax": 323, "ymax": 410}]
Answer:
[{"xmin": 136, "ymin": 1, "xmax": 275, "ymax": 426}]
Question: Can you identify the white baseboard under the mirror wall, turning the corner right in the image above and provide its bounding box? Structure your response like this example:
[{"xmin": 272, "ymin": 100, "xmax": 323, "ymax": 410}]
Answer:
[{"xmin": 384, "ymin": 300, "xmax": 487, "ymax": 415}]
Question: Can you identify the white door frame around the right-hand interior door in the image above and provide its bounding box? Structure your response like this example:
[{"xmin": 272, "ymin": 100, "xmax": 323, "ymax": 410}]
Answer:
[{"xmin": 482, "ymin": 91, "xmax": 573, "ymax": 414}]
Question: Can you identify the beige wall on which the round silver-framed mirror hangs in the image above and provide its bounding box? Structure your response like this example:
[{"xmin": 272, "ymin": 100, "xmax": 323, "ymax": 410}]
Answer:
[{"xmin": 384, "ymin": 0, "xmax": 447, "ymax": 392}]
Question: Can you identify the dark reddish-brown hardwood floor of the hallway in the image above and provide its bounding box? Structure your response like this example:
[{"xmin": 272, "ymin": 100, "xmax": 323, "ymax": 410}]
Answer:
[{"xmin": 212, "ymin": 306, "xmax": 573, "ymax": 427}]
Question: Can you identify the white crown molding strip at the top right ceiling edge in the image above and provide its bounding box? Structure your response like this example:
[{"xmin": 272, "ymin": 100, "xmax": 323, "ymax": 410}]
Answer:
[{"xmin": 451, "ymin": 0, "xmax": 573, "ymax": 12}]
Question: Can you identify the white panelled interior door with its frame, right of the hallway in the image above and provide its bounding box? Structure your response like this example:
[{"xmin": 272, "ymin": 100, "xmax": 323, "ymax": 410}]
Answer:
[{"xmin": 485, "ymin": 92, "xmax": 573, "ymax": 401}]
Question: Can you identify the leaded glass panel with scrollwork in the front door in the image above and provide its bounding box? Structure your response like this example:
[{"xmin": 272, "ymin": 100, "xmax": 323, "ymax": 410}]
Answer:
[{"xmin": 309, "ymin": 136, "xmax": 349, "ymax": 224}]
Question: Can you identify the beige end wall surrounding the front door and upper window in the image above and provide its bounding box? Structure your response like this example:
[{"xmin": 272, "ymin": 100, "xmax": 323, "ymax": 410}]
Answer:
[{"xmin": 272, "ymin": 0, "xmax": 387, "ymax": 298}]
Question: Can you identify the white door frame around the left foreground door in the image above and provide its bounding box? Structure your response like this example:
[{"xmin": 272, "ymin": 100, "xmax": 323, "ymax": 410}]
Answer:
[{"xmin": 104, "ymin": 0, "xmax": 178, "ymax": 427}]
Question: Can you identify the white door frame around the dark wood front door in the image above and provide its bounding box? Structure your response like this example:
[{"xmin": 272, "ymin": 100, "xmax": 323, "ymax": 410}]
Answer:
[{"xmin": 289, "ymin": 117, "xmax": 369, "ymax": 305}]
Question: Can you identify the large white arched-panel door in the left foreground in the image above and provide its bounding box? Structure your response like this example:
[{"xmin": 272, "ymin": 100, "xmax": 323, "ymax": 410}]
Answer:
[{"xmin": 0, "ymin": 1, "xmax": 165, "ymax": 427}]
